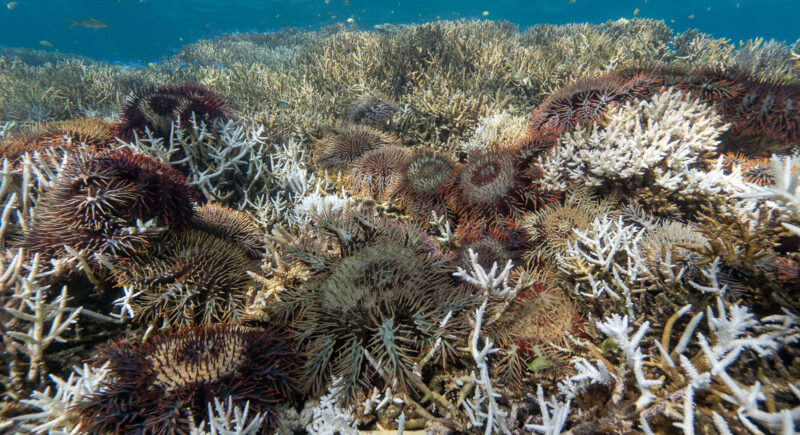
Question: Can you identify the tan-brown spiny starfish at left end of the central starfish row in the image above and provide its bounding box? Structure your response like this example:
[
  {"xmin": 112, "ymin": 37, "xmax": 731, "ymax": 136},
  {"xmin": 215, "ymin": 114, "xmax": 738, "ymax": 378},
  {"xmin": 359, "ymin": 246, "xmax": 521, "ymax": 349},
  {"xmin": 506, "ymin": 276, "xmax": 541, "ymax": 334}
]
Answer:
[{"xmin": 314, "ymin": 125, "xmax": 399, "ymax": 171}]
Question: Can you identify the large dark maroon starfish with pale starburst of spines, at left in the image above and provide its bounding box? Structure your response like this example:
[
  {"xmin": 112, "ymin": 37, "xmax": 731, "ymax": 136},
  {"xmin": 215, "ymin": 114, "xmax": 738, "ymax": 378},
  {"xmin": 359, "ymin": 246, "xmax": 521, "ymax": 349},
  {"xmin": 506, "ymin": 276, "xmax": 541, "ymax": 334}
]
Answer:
[{"xmin": 20, "ymin": 150, "xmax": 194, "ymax": 262}]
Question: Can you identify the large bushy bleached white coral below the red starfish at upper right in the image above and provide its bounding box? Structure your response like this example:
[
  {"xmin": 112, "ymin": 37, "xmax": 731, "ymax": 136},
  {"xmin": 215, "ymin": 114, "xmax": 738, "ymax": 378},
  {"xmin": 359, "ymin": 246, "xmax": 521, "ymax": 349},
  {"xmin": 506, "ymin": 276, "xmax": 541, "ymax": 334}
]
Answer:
[{"xmin": 542, "ymin": 89, "xmax": 747, "ymax": 195}]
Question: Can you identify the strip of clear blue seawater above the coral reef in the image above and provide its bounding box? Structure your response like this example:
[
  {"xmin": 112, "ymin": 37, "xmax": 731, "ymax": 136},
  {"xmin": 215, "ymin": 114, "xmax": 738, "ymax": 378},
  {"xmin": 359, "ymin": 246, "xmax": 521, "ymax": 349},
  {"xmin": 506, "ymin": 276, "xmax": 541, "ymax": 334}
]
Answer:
[{"xmin": 0, "ymin": 0, "xmax": 800, "ymax": 63}]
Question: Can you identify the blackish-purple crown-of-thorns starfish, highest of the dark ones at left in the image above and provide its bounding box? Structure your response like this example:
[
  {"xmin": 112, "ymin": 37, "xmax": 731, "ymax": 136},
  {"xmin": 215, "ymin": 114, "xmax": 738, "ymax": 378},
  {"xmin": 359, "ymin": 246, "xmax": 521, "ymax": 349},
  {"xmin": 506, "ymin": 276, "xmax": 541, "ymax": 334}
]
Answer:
[{"xmin": 114, "ymin": 83, "xmax": 231, "ymax": 140}]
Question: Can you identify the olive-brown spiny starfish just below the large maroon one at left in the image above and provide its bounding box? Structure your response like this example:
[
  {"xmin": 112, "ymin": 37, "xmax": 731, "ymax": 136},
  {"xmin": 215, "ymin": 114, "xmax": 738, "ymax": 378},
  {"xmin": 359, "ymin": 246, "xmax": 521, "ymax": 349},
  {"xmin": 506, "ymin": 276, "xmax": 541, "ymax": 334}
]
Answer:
[{"xmin": 113, "ymin": 229, "xmax": 255, "ymax": 325}]
